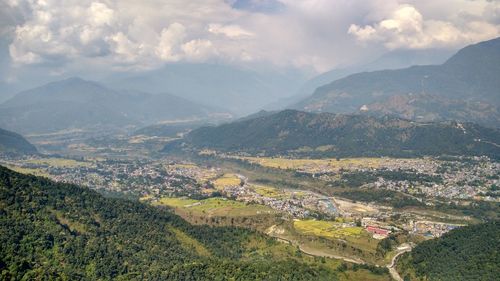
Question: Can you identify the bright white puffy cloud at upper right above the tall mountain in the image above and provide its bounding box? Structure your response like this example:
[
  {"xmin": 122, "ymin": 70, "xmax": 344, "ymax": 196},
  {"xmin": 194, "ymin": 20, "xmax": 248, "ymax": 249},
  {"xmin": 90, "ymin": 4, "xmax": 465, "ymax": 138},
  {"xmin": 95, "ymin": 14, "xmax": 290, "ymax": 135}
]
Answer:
[{"xmin": 348, "ymin": 5, "xmax": 500, "ymax": 49}]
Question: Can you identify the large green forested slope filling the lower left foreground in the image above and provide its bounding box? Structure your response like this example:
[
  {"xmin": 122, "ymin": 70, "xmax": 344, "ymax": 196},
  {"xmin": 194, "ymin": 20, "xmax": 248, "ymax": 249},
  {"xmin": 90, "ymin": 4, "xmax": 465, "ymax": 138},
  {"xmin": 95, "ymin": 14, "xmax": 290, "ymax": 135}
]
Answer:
[{"xmin": 0, "ymin": 166, "xmax": 388, "ymax": 280}]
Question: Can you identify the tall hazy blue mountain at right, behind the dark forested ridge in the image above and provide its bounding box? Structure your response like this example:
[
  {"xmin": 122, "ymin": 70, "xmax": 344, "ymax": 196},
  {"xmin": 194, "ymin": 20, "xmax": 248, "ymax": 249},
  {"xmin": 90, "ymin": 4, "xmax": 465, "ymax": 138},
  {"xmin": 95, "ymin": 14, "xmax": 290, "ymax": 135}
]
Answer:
[{"xmin": 293, "ymin": 38, "xmax": 500, "ymax": 127}]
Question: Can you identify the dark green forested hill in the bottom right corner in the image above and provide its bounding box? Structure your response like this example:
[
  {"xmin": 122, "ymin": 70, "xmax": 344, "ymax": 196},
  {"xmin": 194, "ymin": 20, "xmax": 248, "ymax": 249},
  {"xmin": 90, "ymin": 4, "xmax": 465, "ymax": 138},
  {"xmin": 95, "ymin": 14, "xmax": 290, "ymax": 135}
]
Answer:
[{"xmin": 397, "ymin": 221, "xmax": 500, "ymax": 281}]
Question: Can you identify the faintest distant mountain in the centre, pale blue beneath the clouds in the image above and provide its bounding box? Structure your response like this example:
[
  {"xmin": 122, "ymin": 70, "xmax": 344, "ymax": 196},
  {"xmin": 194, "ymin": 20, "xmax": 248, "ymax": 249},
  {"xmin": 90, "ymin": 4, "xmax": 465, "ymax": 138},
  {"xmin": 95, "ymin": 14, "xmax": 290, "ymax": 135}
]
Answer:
[{"xmin": 103, "ymin": 63, "xmax": 305, "ymax": 115}]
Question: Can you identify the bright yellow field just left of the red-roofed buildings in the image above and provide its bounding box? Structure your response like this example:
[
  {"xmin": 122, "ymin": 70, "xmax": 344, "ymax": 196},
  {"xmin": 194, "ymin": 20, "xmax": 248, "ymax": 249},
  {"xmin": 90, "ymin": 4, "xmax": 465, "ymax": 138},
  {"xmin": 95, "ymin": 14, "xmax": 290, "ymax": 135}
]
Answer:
[{"xmin": 293, "ymin": 220, "xmax": 363, "ymax": 239}]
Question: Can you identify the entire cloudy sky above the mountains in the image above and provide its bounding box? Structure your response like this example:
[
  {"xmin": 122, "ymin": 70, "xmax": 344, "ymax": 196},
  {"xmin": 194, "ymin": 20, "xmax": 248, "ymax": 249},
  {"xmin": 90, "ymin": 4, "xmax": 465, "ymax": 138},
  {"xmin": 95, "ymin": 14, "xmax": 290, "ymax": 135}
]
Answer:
[{"xmin": 0, "ymin": 0, "xmax": 500, "ymax": 83}]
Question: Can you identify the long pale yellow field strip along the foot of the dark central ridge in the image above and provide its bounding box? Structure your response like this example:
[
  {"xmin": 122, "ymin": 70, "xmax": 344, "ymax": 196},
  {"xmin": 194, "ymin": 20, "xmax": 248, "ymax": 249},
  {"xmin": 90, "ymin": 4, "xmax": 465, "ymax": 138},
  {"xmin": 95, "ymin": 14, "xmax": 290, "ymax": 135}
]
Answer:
[{"xmin": 240, "ymin": 157, "xmax": 382, "ymax": 173}]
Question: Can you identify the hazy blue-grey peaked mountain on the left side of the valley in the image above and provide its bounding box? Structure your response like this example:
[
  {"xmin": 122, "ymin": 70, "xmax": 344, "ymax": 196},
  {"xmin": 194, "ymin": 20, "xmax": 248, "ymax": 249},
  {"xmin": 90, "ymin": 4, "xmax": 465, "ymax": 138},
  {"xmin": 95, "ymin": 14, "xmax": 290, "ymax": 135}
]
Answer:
[{"xmin": 0, "ymin": 78, "xmax": 227, "ymax": 133}]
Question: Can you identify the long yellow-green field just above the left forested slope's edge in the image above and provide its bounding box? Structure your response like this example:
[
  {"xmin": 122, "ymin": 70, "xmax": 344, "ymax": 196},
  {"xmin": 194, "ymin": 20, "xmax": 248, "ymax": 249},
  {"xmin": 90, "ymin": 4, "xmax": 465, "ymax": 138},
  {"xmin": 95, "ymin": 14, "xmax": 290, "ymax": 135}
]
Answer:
[{"xmin": 153, "ymin": 197, "xmax": 275, "ymax": 216}]
